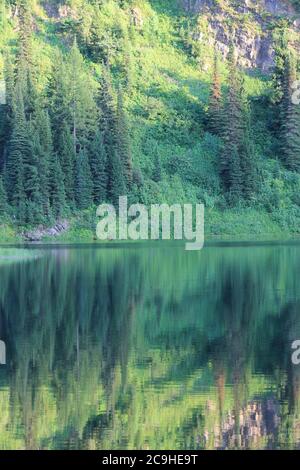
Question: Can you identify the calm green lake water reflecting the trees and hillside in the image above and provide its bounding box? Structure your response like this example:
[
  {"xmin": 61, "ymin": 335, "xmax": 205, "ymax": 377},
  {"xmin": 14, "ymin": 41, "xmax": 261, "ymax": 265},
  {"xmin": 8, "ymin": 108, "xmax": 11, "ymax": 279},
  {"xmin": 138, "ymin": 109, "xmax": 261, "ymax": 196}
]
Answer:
[{"xmin": 0, "ymin": 244, "xmax": 300, "ymax": 450}]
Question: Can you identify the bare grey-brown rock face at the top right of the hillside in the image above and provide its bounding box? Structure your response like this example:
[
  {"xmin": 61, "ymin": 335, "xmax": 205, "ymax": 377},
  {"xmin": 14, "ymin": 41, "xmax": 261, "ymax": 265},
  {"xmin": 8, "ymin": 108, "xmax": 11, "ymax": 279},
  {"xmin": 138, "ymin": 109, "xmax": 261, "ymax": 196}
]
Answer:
[{"xmin": 183, "ymin": 0, "xmax": 300, "ymax": 72}]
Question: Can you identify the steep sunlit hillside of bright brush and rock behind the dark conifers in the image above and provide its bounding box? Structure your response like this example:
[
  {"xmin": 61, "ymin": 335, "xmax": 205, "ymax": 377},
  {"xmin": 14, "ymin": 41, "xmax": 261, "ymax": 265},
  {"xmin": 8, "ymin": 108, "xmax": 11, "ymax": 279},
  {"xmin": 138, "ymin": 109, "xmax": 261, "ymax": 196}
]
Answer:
[{"xmin": 0, "ymin": 0, "xmax": 300, "ymax": 241}]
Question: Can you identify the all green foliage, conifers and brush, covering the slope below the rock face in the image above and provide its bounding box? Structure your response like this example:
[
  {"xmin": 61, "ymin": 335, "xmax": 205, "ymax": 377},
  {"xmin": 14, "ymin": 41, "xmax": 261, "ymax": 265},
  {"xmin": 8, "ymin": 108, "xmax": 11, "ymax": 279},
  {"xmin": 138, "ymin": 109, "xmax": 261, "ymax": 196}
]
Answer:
[{"xmin": 0, "ymin": 0, "xmax": 299, "ymax": 235}]
